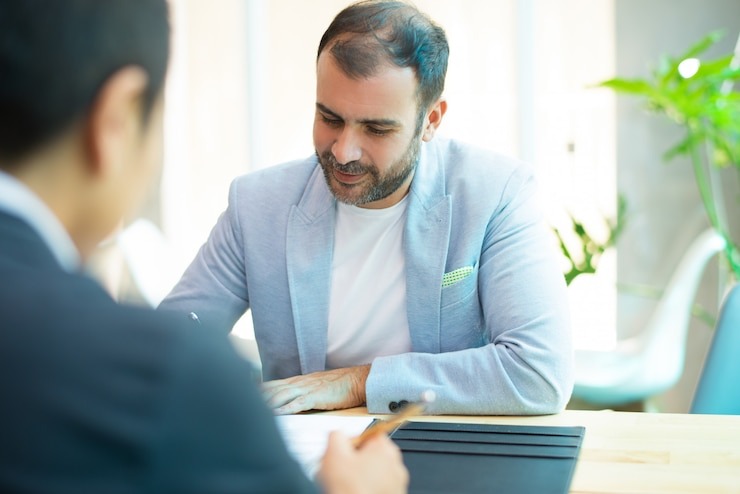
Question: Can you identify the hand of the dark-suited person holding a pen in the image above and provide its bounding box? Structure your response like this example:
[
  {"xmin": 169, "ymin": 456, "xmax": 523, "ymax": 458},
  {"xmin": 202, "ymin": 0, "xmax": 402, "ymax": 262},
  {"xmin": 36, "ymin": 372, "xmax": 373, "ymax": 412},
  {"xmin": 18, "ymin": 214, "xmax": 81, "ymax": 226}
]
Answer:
[{"xmin": 316, "ymin": 432, "xmax": 409, "ymax": 494}]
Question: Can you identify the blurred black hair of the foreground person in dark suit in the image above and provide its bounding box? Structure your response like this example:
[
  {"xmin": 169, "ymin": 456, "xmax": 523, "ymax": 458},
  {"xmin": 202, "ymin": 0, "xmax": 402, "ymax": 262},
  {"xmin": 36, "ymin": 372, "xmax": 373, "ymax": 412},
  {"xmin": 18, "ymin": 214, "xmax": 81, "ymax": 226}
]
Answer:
[{"xmin": 0, "ymin": 0, "xmax": 170, "ymax": 165}]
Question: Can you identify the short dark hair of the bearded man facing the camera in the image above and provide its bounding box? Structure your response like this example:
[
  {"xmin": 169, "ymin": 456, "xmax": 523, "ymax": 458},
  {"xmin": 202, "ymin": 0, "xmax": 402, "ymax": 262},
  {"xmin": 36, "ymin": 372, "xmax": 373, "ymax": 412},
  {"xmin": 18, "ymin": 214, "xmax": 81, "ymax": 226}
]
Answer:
[{"xmin": 317, "ymin": 0, "xmax": 450, "ymax": 117}]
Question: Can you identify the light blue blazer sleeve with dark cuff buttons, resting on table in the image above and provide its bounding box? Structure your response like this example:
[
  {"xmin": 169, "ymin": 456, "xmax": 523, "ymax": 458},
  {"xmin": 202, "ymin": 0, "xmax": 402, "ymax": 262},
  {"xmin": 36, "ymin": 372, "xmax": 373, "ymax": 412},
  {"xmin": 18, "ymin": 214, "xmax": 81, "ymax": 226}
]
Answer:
[{"xmin": 366, "ymin": 167, "xmax": 573, "ymax": 415}]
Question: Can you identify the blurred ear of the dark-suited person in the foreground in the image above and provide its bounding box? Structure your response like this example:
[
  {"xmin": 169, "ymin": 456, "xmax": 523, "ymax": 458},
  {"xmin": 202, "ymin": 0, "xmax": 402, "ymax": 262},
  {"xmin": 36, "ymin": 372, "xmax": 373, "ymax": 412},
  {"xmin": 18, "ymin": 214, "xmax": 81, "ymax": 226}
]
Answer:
[{"xmin": 85, "ymin": 66, "xmax": 148, "ymax": 175}]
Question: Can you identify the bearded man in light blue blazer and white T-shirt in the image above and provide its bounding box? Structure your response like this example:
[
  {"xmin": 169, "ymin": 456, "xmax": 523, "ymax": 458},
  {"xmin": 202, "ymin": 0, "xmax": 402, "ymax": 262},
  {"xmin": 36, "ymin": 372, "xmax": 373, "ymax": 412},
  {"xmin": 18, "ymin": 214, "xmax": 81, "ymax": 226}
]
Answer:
[{"xmin": 161, "ymin": 0, "xmax": 573, "ymax": 414}]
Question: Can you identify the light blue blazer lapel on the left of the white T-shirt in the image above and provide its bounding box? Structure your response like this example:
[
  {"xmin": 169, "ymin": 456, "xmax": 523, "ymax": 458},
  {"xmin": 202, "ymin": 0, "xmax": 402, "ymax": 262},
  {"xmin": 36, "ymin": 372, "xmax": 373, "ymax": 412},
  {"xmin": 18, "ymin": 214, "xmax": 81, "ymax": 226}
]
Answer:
[{"xmin": 286, "ymin": 166, "xmax": 336, "ymax": 374}]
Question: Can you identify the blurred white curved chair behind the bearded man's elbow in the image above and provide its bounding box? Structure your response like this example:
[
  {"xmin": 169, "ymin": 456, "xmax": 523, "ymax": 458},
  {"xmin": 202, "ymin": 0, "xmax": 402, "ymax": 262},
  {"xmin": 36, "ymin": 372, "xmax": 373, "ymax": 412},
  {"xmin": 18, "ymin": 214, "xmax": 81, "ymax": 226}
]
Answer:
[{"xmin": 573, "ymin": 229, "xmax": 725, "ymax": 406}]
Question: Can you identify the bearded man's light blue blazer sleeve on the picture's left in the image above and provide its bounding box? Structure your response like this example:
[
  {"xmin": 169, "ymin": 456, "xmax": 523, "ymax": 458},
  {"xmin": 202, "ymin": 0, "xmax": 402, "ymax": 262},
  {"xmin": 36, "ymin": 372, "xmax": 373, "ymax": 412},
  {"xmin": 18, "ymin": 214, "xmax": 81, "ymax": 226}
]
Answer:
[{"xmin": 158, "ymin": 181, "xmax": 249, "ymax": 333}]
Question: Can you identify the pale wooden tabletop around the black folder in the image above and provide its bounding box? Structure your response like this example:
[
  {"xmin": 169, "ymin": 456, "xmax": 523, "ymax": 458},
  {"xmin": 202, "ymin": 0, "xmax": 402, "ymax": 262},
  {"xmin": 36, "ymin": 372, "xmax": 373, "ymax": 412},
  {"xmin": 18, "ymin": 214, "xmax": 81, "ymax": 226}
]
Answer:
[{"xmin": 328, "ymin": 408, "xmax": 740, "ymax": 494}]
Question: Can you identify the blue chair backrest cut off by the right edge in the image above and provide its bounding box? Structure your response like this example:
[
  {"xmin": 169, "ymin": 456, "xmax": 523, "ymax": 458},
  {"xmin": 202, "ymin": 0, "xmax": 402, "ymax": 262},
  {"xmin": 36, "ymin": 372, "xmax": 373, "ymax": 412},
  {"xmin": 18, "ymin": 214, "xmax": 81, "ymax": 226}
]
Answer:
[{"xmin": 691, "ymin": 284, "xmax": 740, "ymax": 415}]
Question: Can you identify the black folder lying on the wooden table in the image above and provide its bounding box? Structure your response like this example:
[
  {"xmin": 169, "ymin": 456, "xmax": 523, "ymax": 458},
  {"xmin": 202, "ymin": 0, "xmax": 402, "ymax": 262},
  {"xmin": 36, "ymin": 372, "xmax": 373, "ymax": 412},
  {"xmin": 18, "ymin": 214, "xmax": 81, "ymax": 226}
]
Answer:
[{"xmin": 391, "ymin": 422, "xmax": 585, "ymax": 494}]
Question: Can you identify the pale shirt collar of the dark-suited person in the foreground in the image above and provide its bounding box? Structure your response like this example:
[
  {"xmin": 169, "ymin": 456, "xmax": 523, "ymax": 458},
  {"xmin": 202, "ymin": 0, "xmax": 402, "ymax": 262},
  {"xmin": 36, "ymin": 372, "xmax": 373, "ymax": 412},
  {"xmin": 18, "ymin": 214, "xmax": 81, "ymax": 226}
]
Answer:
[{"xmin": 0, "ymin": 171, "xmax": 81, "ymax": 272}]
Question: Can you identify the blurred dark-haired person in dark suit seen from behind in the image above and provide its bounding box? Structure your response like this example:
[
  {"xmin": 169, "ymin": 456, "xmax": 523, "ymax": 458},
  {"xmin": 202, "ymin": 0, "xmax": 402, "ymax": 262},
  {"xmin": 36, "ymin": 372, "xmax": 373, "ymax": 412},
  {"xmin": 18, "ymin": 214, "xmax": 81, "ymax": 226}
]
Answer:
[{"xmin": 0, "ymin": 0, "xmax": 408, "ymax": 494}]
